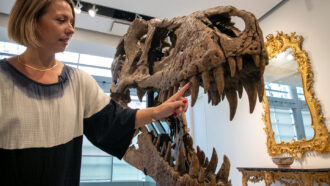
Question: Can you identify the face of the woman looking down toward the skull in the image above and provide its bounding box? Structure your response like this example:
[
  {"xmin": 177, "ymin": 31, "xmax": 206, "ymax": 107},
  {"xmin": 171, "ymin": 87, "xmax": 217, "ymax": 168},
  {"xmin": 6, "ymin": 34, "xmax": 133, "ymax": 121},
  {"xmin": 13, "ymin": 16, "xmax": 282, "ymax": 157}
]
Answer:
[{"xmin": 36, "ymin": 0, "xmax": 74, "ymax": 53}]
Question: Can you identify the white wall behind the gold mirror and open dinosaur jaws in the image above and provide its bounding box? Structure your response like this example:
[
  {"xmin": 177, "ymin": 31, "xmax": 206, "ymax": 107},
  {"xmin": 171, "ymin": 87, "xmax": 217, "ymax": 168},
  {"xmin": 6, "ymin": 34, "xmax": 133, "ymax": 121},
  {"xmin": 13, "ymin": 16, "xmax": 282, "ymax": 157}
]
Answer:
[{"xmin": 188, "ymin": 0, "xmax": 330, "ymax": 186}]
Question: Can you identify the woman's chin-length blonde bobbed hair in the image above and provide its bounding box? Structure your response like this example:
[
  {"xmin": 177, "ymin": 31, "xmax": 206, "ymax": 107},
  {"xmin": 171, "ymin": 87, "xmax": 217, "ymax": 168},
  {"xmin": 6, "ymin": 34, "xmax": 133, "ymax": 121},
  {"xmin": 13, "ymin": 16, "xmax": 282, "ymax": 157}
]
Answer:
[{"xmin": 8, "ymin": 0, "xmax": 75, "ymax": 47}]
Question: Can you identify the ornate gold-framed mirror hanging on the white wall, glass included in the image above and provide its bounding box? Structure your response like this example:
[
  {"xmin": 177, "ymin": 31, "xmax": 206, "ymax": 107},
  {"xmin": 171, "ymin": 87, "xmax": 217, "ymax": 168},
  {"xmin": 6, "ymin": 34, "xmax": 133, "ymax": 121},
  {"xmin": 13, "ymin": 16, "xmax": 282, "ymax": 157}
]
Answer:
[{"xmin": 263, "ymin": 32, "xmax": 330, "ymax": 159}]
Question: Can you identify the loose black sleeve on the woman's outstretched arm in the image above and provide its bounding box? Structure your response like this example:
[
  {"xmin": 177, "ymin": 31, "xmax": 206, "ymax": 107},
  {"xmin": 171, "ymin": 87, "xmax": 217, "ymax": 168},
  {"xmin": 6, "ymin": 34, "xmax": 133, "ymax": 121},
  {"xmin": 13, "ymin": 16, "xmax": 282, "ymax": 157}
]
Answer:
[{"xmin": 84, "ymin": 100, "xmax": 137, "ymax": 159}]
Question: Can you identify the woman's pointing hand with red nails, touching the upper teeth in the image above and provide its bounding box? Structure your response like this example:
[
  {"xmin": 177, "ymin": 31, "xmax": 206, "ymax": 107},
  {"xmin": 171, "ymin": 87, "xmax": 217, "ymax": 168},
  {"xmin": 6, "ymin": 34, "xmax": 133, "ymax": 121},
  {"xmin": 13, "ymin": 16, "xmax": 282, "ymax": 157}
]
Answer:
[{"xmin": 151, "ymin": 83, "xmax": 191, "ymax": 120}]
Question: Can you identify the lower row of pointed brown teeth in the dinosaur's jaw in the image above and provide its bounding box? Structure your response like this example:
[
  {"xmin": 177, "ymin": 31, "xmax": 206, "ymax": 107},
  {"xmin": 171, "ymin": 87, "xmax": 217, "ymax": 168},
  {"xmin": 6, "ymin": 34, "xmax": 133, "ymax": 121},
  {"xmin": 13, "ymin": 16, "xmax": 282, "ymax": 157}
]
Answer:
[{"xmin": 153, "ymin": 133, "xmax": 230, "ymax": 186}]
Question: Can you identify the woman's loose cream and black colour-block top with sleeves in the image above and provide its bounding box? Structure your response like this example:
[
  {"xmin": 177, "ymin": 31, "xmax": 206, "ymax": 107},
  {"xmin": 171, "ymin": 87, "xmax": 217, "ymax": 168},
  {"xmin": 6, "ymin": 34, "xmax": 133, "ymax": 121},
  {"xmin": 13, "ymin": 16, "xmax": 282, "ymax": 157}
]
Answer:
[{"xmin": 0, "ymin": 60, "xmax": 136, "ymax": 186}]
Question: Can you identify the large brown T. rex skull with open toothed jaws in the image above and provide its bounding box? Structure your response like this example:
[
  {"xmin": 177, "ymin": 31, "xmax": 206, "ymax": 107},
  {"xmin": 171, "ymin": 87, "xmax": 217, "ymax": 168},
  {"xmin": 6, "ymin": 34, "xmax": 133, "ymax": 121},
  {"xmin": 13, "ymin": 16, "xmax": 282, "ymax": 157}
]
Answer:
[{"xmin": 111, "ymin": 6, "xmax": 268, "ymax": 185}]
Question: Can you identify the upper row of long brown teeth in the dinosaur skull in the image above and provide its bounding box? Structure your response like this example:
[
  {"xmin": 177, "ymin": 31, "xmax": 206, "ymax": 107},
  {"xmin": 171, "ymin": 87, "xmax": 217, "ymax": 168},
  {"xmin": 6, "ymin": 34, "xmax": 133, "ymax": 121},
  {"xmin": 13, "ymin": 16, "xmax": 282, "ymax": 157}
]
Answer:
[{"xmin": 137, "ymin": 55, "xmax": 266, "ymax": 120}]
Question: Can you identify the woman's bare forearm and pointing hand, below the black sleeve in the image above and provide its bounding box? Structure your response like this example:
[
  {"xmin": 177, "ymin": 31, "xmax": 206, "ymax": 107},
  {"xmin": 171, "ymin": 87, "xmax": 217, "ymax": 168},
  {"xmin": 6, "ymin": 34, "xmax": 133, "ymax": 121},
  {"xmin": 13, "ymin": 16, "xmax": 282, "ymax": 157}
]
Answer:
[{"xmin": 135, "ymin": 83, "xmax": 191, "ymax": 128}]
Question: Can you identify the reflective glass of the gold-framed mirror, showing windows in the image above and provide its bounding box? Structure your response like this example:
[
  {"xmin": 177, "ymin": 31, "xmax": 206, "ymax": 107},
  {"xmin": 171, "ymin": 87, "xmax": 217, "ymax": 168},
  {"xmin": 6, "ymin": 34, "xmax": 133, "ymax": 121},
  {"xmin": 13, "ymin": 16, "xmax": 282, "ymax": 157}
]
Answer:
[{"xmin": 264, "ymin": 48, "xmax": 314, "ymax": 143}]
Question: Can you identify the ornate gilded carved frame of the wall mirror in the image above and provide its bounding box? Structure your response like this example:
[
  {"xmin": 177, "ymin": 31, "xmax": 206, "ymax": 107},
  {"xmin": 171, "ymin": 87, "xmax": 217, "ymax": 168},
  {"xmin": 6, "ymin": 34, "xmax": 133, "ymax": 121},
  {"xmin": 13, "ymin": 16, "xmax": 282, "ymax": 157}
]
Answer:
[{"xmin": 262, "ymin": 32, "xmax": 330, "ymax": 159}]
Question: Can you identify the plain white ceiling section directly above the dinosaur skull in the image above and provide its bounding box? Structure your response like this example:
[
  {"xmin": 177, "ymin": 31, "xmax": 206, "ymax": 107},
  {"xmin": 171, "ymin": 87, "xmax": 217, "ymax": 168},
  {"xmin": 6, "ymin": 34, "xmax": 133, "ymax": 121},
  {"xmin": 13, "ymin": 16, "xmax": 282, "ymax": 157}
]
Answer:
[{"xmin": 82, "ymin": 0, "xmax": 282, "ymax": 18}]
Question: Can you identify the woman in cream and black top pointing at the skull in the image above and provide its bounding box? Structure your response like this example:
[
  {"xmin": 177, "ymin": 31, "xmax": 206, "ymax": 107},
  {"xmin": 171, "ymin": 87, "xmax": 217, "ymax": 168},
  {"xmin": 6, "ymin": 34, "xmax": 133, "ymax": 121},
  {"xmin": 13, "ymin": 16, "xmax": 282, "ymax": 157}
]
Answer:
[{"xmin": 0, "ymin": 0, "xmax": 190, "ymax": 186}]
